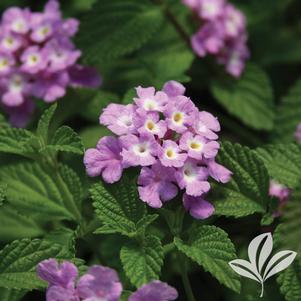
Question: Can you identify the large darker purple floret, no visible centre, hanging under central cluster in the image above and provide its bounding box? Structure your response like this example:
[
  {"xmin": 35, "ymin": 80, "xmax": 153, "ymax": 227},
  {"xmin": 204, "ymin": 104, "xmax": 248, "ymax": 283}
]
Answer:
[{"xmin": 138, "ymin": 162, "xmax": 178, "ymax": 208}]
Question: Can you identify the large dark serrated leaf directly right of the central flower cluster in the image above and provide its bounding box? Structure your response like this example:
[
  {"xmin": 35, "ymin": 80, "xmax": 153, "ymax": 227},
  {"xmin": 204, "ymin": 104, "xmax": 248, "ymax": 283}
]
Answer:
[{"xmin": 211, "ymin": 142, "xmax": 270, "ymax": 217}]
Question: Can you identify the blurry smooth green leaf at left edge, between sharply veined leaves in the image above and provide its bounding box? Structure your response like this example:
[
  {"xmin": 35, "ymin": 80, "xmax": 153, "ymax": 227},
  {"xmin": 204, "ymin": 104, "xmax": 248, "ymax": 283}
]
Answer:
[{"xmin": 0, "ymin": 204, "xmax": 44, "ymax": 240}]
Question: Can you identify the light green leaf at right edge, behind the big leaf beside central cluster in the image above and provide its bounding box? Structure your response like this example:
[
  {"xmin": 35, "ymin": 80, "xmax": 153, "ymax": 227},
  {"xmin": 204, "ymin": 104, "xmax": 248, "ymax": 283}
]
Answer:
[{"xmin": 256, "ymin": 143, "xmax": 301, "ymax": 188}]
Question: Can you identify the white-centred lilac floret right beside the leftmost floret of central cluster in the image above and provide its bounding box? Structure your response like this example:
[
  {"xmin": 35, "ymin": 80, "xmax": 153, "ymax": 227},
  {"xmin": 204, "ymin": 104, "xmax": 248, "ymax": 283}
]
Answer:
[{"xmin": 120, "ymin": 134, "xmax": 159, "ymax": 166}]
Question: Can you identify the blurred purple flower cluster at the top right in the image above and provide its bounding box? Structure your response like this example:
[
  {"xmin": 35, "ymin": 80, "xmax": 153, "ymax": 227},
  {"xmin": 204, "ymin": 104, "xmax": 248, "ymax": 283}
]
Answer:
[{"xmin": 183, "ymin": 0, "xmax": 249, "ymax": 77}]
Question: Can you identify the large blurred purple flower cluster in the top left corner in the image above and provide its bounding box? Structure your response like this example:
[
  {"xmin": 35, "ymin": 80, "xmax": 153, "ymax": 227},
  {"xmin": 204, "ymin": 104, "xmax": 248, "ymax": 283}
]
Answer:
[{"xmin": 0, "ymin": 0, "xmax": 100, "ymax": 126}]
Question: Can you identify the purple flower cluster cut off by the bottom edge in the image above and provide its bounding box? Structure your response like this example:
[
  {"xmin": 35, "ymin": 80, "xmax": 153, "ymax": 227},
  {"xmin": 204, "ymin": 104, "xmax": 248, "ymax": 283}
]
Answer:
[{"xmin": 37, "ymin": 259, "xmax": 178, "ymax": 301}]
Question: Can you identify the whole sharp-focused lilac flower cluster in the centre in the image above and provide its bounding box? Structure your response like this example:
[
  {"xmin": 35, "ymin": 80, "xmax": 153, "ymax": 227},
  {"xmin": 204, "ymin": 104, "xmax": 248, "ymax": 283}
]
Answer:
[{"xmin": 84, "ymin": 81, "xmax": 231, "ymax": 219}]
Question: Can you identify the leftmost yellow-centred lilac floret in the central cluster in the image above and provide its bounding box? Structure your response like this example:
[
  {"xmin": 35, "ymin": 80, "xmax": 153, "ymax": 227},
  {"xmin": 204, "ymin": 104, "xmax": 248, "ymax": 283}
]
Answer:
[{"xmin": 134, "ymin": 111, "xmax": 167, "ymax": 138}]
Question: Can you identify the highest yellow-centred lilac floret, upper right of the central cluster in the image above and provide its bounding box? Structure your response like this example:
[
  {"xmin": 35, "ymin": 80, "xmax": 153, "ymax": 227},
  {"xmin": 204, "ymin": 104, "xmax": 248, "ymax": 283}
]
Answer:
[{"xmin": 164, "ymin": 96, "xmax": 197, "ymax": 133}]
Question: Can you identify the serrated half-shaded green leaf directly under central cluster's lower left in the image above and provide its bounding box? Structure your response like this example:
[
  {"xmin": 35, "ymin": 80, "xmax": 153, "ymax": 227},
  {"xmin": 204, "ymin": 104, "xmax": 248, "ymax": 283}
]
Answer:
[{"xmin": 90, "ymin": 175, "xmax": 145, "ymax": 236}]
